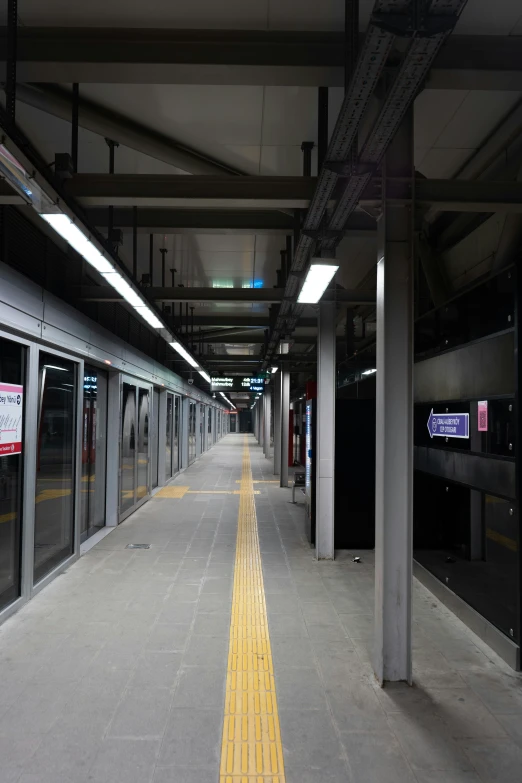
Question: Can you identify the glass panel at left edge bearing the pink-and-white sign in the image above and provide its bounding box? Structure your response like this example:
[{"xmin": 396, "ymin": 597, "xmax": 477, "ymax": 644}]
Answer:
[{"xmin": 0, "ymin": 338, "xmax": 26, "ymax": 610}]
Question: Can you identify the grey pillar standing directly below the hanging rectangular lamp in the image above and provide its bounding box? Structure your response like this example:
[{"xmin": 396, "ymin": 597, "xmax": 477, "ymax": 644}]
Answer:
[{"xmin": 314, "ymin": 302, "xmax": 336, "ymax": 560}]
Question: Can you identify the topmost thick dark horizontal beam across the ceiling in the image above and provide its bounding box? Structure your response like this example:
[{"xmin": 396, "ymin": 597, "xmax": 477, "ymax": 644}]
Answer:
[{"xmin": 0, "ymin": 27, "xmax": 522, "ymax": 91}]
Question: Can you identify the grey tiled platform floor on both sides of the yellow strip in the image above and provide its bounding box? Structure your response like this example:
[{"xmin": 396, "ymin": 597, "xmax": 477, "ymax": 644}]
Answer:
[{"xmin": 0, "ymin": 435, "xmax": 522, "ymax": 783}]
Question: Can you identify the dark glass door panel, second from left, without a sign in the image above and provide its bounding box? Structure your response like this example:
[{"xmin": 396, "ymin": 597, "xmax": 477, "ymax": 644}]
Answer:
[{"xmin": 34, "ymin": 352, "xmax": 77, "ymax": 582}]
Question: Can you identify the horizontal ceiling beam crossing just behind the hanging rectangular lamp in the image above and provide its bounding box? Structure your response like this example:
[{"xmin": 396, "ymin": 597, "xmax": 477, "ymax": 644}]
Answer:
[{"xmin": 80, "ymin": 286, "xmax": 375, "ymax": 305}]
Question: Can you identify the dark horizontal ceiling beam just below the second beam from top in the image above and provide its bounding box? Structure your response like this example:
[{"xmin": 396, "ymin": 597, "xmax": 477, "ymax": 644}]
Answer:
[{"xmin": 86, "ymin": 207, "xmax": 376, "ymax": 238}]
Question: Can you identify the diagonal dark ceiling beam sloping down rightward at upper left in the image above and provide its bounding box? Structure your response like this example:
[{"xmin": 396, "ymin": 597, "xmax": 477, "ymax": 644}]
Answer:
[{"xmin": 12, "ymin": 83, "xmax": 242, "ymax": 174}]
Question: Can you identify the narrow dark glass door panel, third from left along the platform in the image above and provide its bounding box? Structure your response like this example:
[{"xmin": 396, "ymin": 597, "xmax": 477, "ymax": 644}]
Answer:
[{"xmin": 80, "ymin": 364, "xmax": 108, "ymax": 542}]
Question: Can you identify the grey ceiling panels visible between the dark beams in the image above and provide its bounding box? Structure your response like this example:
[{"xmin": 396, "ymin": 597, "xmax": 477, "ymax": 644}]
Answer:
[{"xmin": 6, "ymin": 0, "xmax": 522, "ymax": 384}]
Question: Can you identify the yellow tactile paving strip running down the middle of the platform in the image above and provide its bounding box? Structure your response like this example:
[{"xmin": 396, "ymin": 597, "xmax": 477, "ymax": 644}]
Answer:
[{"xmin": 220, "ymin": 437, "xmax": 285, "ymax": 783}]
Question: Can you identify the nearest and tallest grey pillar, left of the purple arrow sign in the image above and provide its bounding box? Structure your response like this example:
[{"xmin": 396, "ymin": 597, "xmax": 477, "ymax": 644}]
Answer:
[{"xmin": 374, "ymin": 111, "xmax": 414, "ymax": 684}]
